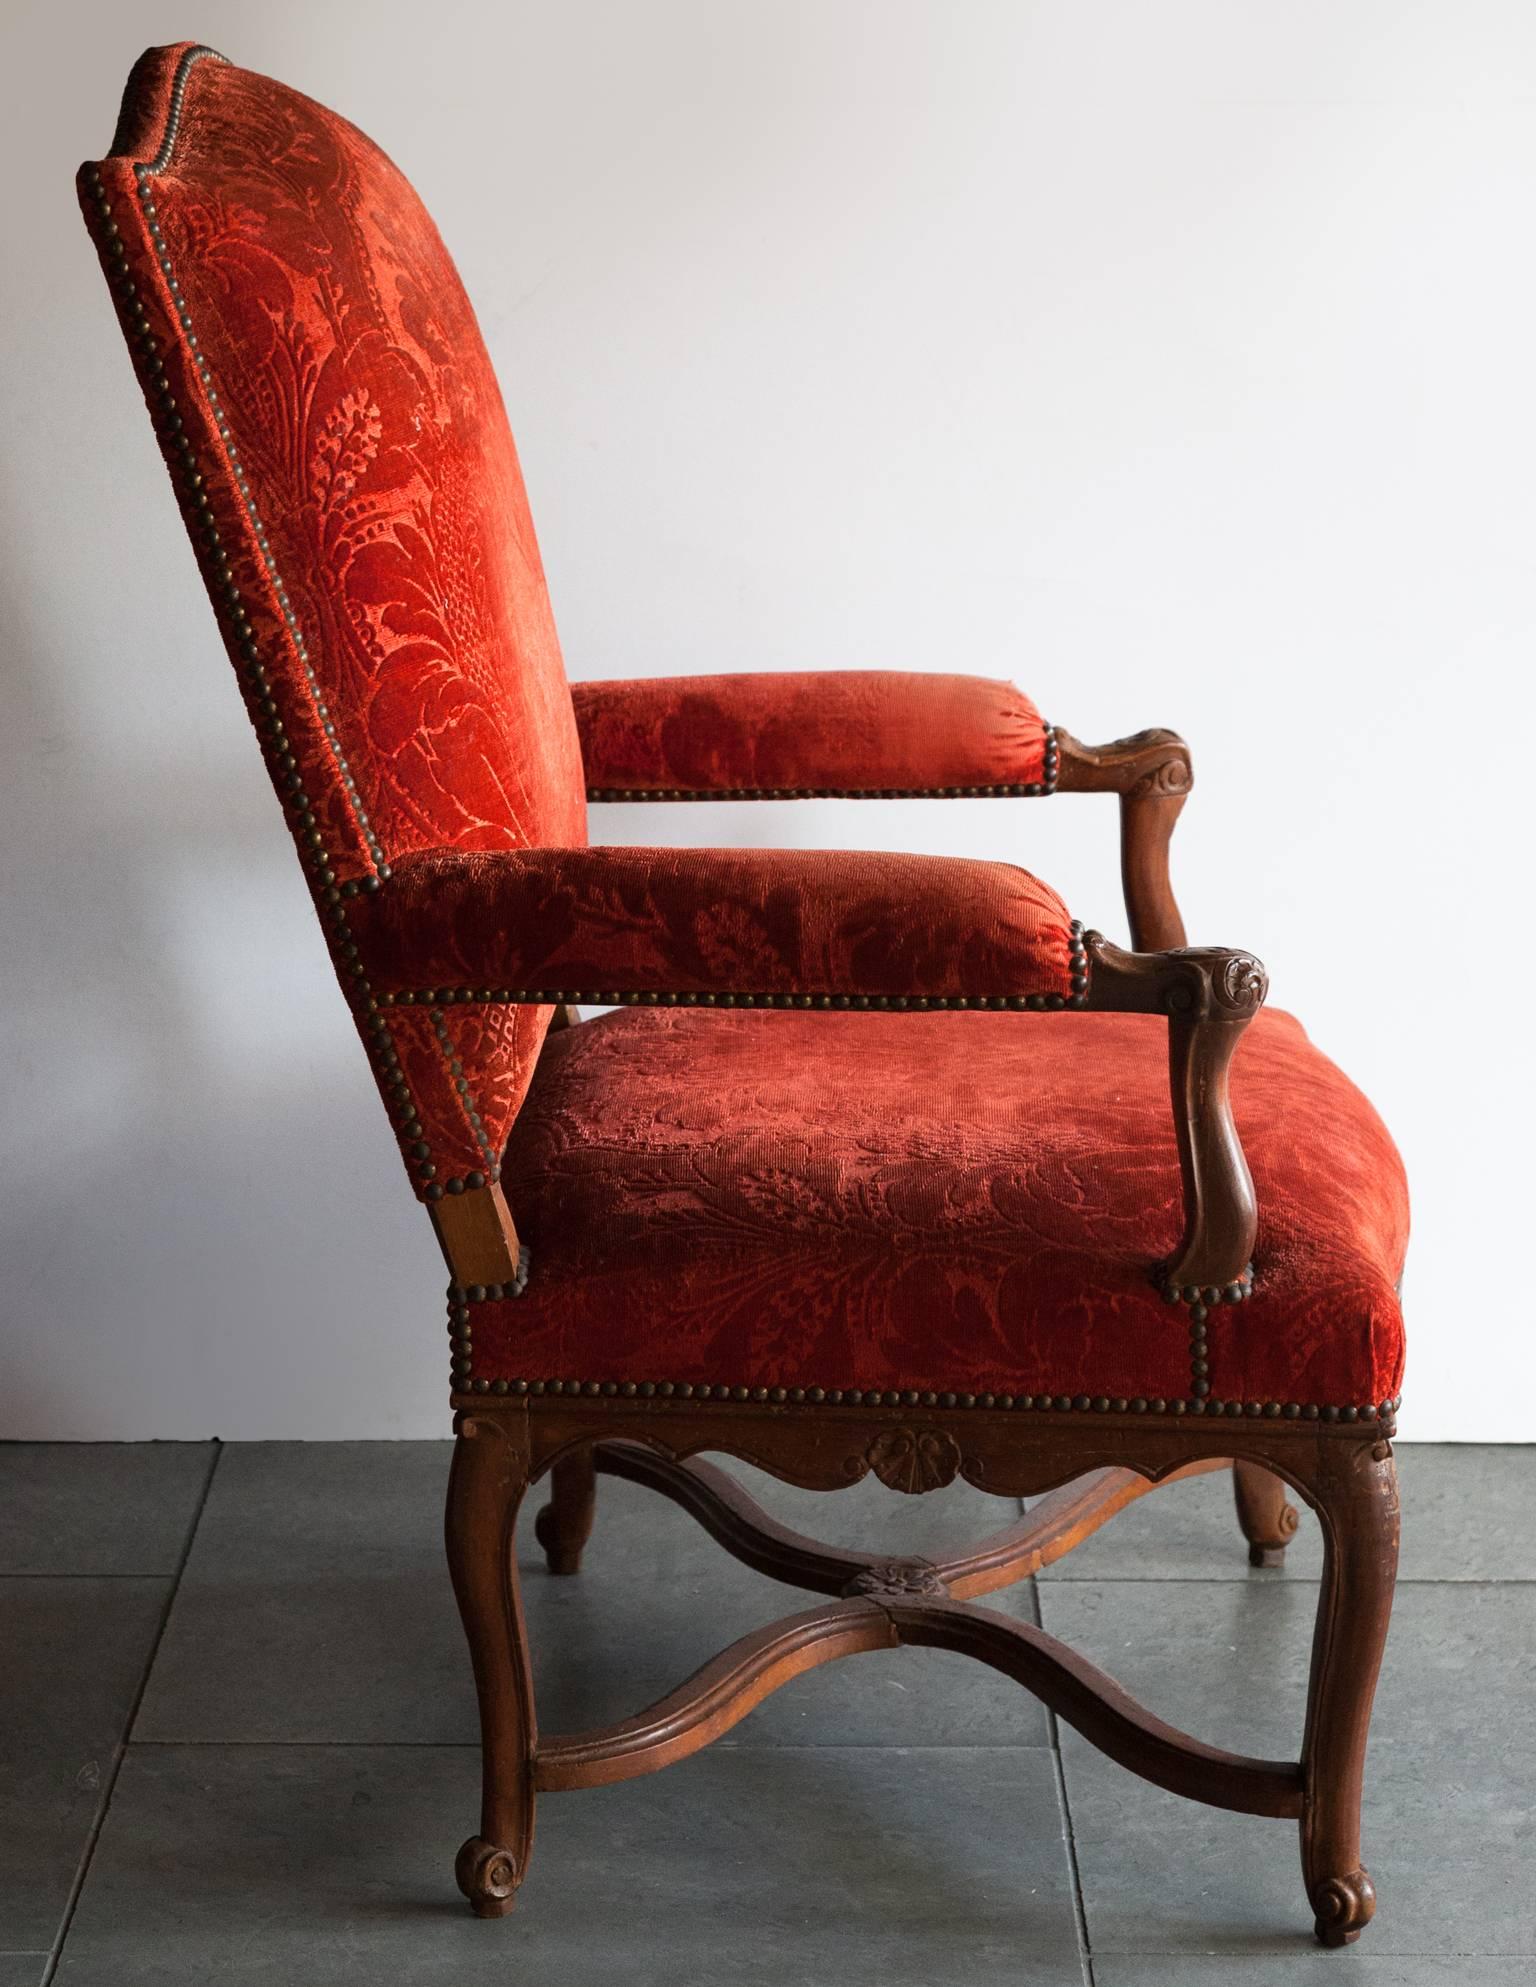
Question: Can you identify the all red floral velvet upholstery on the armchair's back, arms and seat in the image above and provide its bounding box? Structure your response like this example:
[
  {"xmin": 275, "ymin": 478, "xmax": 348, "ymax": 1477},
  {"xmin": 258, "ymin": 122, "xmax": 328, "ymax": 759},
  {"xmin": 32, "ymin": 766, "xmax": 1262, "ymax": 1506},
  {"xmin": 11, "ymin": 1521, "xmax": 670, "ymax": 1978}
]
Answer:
[{"xmin": 79, "ymin": 46, "xmax": 1407, "ymax": 1438}]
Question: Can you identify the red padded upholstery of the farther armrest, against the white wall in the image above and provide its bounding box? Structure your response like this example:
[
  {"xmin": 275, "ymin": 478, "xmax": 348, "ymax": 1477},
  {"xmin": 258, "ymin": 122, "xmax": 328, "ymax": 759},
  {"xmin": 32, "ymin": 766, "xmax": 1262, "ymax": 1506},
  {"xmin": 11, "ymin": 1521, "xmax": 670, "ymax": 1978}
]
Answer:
[{"xmin": 572, "ymin": 670, "xmax": 1045, "ymax": 793}]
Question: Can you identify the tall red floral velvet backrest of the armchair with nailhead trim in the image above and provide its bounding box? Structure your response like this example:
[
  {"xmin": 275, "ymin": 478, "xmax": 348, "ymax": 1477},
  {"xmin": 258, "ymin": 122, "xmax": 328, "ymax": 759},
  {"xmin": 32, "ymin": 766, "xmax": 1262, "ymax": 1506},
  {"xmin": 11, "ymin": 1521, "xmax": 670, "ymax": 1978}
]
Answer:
[{"xmin": 79, "ymin": 46, "xmax": 586, "ymax": 1186}]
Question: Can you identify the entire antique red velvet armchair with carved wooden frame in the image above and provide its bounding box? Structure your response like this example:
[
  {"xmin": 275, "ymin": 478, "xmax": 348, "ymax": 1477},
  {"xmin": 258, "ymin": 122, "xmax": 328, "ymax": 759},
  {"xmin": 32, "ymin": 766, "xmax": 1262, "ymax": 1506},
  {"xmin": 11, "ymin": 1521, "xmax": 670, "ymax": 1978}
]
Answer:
[{"xmin": 79, "ymin": 46, "xmax": 1407, "ymax": 1943}]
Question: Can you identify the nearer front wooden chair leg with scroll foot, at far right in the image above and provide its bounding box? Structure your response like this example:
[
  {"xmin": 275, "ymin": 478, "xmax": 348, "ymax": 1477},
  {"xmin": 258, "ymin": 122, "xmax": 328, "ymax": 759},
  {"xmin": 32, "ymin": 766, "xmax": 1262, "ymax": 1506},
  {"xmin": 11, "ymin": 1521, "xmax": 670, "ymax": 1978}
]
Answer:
[{"xmin": 1302, "ymin": 1441, "xmax": 1397, "ymax": 1945}]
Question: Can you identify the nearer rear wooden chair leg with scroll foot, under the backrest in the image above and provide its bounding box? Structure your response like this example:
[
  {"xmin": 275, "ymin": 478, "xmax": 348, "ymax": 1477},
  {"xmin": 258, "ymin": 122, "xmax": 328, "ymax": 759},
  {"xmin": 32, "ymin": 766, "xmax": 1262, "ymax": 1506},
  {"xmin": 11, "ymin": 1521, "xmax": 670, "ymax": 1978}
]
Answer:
[{"xmin": 445, "ymin": 1413, "xmax": 537, "ymax": 1917}]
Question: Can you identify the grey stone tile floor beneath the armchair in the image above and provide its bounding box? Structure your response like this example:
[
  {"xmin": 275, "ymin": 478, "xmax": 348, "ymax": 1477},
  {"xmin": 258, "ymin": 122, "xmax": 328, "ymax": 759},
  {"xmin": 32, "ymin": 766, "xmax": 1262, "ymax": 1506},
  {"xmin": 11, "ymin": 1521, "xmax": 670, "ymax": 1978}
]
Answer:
[{"xmin": 0, "ymin": 1443, "xmax": 1536, "ymax": 1987}]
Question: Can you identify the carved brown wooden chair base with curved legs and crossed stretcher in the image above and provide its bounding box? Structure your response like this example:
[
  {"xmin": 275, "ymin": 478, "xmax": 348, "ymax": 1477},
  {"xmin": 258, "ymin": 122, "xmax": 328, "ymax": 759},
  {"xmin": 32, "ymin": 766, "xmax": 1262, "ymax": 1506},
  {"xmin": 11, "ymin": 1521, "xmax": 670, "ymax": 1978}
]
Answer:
[{"xmin": 447, "ymin": 1397, "xmax": 1397, "ymax": 1945}]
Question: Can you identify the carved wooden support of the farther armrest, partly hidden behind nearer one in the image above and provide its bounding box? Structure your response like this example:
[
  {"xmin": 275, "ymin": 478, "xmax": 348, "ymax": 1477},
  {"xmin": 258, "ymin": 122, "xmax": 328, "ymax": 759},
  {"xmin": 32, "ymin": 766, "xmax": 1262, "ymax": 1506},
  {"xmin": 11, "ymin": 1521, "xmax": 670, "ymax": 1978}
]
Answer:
[{"xmin": 1055, "ymin": 725, "xmax": 1194, "ymax": 952}]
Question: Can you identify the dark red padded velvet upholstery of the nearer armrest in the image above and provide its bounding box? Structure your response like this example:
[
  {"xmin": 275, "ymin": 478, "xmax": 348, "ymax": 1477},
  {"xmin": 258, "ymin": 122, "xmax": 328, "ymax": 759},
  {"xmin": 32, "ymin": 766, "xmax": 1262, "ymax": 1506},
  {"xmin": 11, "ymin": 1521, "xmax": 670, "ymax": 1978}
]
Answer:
[{"xmin": 352, "ymin": 848, "xmax": 1087, "ymax": 1007}]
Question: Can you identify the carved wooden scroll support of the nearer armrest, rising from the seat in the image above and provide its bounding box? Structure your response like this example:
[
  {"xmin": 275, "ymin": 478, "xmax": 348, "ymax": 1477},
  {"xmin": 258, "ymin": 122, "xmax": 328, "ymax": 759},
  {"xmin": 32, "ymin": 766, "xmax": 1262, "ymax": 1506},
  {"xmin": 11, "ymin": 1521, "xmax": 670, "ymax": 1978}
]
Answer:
[{"xmin": 1085, "ymin": 932, "xmax": 1270, "ymax": 1303}]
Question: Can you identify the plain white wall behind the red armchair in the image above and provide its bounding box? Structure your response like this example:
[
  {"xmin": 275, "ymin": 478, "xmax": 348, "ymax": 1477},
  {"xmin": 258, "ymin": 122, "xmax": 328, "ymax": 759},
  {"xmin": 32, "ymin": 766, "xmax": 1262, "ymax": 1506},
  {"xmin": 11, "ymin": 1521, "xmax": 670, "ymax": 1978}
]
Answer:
[{"xmin": 0, "ymin": 0, "xmax": 1536, "ymax": 1441}]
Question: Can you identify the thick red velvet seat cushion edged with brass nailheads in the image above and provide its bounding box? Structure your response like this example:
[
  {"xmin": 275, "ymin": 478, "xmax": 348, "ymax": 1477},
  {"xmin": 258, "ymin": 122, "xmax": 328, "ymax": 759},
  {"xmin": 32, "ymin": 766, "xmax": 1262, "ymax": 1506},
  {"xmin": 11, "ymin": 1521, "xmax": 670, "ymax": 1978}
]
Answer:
[{"xmin": 469, "ymin": 1009, "xmax": 1407, "ymax": 1419}]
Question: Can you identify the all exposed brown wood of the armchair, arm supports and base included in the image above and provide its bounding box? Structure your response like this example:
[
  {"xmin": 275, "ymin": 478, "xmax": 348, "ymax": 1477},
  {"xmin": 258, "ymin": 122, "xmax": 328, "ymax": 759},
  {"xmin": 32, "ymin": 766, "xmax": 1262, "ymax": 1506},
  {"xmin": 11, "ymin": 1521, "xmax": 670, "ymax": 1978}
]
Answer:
[{"xmin": 431, "ymin": 731, "xmax": 1397, "ymax": 1945}]
